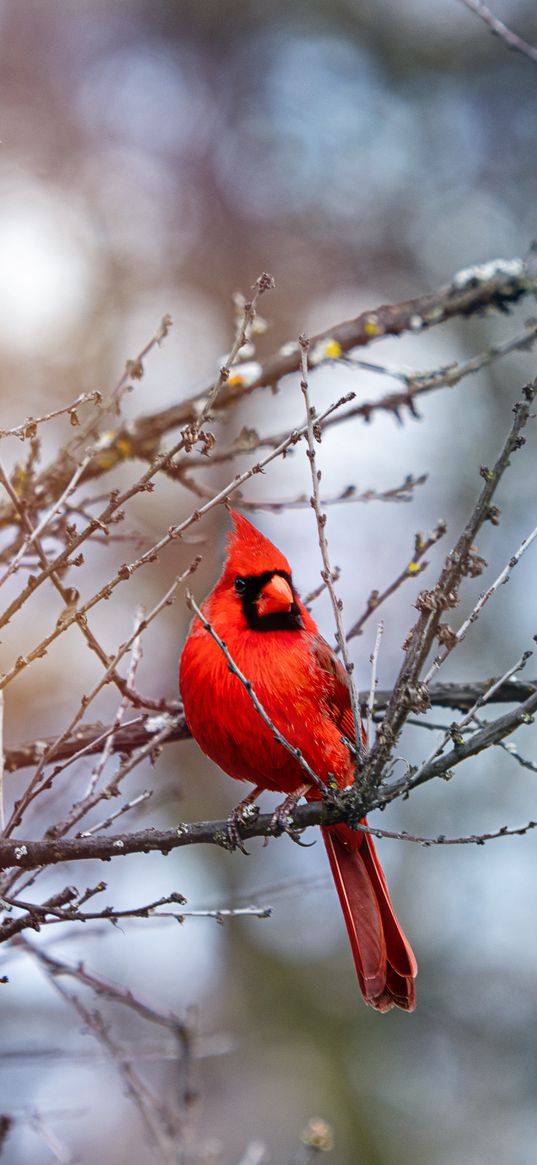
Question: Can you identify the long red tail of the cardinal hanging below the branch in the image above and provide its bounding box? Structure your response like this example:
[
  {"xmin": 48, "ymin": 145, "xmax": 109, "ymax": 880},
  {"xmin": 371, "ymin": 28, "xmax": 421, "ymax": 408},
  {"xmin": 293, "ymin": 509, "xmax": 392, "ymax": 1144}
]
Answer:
[{"xmin": 322, "ymin": 825, "xmax": 417, "ymax": 1011}]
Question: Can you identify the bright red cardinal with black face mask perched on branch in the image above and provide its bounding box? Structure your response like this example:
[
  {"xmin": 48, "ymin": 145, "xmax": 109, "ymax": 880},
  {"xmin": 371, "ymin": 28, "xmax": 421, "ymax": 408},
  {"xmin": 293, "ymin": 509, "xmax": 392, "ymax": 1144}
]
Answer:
[{"xmin": 179, "ymin": 513, "xmax": 417, "ymax": 1011}]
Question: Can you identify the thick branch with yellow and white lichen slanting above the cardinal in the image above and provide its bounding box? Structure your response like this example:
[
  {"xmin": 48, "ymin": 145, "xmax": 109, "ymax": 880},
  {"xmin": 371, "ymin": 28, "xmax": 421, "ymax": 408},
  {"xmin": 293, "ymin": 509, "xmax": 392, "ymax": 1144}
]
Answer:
[{"xmin": 0, "ymin": 253, "xmax": 537, "ymax": 525}]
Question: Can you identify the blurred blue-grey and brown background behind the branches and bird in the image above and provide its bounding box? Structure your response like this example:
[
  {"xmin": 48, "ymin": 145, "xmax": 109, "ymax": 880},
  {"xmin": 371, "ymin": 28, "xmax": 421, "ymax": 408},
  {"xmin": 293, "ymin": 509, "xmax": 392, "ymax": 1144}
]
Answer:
[{"xmin": 0, "ymin": 0, "xmax": 537, "ymax": 1165}]
